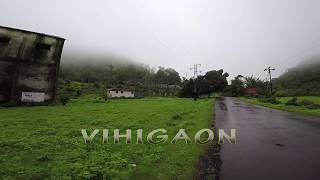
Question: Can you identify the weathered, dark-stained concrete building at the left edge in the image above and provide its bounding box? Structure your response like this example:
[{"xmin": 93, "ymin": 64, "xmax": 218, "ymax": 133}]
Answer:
[{"xmin": 0, "ymin": 26, "xmax": 65, "ymax": 104}]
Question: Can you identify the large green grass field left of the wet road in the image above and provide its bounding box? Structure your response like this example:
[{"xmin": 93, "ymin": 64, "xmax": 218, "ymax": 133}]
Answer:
[{"xmin": 0, "ymin": 98, "xmax": 213, "ymax": 179}]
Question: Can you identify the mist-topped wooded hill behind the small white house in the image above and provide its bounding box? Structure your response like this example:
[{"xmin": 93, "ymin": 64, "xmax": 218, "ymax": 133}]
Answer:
[{"xmin": 60, "ymin": 50, "xmax": 181, "ymax": 86}]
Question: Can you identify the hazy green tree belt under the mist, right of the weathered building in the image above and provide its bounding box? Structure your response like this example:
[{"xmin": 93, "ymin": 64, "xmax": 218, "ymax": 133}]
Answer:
[{"xmin": 60, "ymin": 62, "xmax": 181, "ymax": 86}]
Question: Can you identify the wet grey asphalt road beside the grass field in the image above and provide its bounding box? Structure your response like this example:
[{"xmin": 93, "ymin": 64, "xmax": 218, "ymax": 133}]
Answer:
[{"xmin": 216, "ymin": 98, "xmax": 320, "ymax": 180}]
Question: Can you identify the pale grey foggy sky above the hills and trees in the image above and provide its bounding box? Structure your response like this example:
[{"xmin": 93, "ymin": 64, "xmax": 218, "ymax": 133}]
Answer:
[{"xmin": 0, "ymin": 0, "xmax": 320, "ymax": 79}]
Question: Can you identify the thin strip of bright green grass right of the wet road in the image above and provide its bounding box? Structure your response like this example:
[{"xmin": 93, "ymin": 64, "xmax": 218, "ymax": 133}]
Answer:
[{"xmin": 239, "ymin": 97, "xmax": 320, "ymax": 116}]
